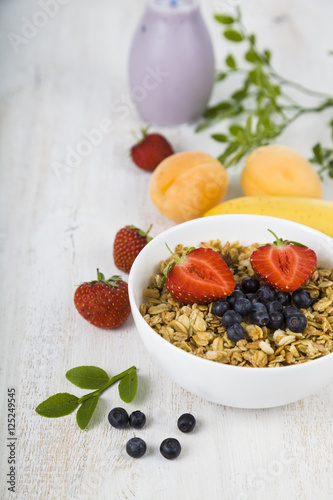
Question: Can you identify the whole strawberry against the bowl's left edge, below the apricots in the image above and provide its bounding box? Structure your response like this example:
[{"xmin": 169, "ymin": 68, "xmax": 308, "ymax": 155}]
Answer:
[{"xmin": 113, "ymin": 226, "xmax": 152, "ymax": 273}]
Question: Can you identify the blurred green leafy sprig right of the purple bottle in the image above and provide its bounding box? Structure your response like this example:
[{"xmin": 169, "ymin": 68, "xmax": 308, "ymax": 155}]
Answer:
[{"xmin": 196, "ymin": 8, "xmax": 333, "ymax": 177}]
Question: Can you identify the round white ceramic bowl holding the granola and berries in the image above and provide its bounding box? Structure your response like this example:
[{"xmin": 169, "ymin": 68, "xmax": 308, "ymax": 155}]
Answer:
[{"xmin": 129, "ymin": 215, "xmax": 333, "ymax": 408}]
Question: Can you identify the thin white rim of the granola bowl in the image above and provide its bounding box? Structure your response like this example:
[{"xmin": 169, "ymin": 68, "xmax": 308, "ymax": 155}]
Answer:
[{"xmin": 128, "ymin": 214, "xmax": 333, "ymax": 373}]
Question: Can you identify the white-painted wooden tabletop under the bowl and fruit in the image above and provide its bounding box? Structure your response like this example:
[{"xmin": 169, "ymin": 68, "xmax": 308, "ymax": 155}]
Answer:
[{"xmin": 0, "ymin": 0, "xmax": 333, "ymax": 500}]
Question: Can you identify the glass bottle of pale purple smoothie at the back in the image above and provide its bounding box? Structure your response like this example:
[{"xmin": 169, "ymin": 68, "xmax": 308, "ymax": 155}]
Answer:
[{"xmin": 129, "ymin": 0, "xmax": 215, "ymax": 126}]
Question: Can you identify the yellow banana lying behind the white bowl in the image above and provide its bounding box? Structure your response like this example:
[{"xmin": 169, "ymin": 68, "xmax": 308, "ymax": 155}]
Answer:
[{"xmin": 204, "ymin": 196, "xmax": 333, "ymax": 238}]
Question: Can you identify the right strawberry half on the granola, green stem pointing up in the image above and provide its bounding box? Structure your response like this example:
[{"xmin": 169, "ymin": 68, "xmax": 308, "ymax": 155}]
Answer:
[{"xmin": 250, "ymin": 230, "xmax": 317, "ymax": 292}]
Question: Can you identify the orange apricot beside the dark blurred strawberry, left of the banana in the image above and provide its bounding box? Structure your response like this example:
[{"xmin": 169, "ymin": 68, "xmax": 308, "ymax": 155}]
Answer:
[{"xmin": 149, "ymin": 152, "xmax": 229, "ymax": 222}]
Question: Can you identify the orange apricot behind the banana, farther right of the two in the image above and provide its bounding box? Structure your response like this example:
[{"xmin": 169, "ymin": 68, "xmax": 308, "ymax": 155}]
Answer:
[{"xmin": 241, "ymin": 144, "xmax": 322, "ymax": 198}]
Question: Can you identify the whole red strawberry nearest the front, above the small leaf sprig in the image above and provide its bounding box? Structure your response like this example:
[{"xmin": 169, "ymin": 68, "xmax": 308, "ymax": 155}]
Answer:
[{"xmin": 74, "ymin": 269, "xmax": 131, "ymax": 329}]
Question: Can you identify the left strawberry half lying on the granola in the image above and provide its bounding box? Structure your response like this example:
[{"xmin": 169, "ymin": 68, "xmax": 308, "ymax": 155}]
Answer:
[{"xmin": 165, "ymin": 248, "xmax": 236, "ymax": 304}]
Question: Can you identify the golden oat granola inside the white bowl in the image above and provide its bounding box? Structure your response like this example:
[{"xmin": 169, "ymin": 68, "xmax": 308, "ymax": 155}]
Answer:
[{"xmin": 139, "ymin": 239, "xmax": 333, "ymax": 367}]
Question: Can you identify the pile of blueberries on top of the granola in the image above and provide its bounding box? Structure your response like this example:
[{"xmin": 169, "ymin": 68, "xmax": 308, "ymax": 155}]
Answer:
[{"xmin": 212, "ymin": 277, "xmax": 313, "ymax": 342}]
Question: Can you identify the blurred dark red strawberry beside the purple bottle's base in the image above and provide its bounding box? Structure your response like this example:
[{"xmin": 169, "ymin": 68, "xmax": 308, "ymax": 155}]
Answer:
[{"xmin": 131, "ymin": 129, "xmax": 174, "ymax": 172}]
